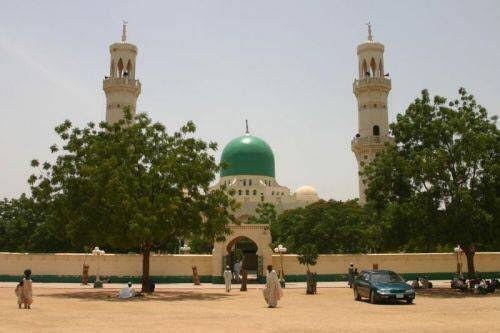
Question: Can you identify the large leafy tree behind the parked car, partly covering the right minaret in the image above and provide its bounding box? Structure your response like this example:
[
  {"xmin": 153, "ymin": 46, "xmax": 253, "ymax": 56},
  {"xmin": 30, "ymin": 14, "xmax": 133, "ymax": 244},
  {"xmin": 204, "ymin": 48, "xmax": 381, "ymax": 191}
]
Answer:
[{"xmin": 364, "ymin": 88, "xmax": 500, "ymax": 277}]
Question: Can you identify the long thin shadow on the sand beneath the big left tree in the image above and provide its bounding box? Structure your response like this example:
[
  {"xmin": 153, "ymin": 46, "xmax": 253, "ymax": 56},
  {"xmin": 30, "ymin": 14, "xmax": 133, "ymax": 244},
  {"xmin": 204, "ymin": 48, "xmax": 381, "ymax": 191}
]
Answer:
[{"xmin": 37, "ymin": 290, "xmax": 231, "ymax": 302}]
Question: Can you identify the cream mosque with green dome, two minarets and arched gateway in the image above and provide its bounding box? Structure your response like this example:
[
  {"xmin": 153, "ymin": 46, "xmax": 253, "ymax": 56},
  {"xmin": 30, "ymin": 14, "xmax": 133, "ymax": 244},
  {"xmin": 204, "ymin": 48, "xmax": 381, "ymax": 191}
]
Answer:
[{"xmin": 103, "ymin": 22, "xmax": 393, "ymax": 276}]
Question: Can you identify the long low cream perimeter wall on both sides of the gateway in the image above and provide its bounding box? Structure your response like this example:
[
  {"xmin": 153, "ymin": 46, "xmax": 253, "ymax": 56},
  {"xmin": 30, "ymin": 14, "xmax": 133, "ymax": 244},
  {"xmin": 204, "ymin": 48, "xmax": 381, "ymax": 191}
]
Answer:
[{"xmin": 0, "ymin": 252, "xmax": 500, "ymax": 283}]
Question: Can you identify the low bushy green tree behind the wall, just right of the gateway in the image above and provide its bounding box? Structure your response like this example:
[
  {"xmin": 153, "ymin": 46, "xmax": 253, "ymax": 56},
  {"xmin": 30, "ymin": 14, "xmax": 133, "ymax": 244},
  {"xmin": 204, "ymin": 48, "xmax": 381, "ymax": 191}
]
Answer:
[{"xmin": 271, "ymin": 200, "xmax": 372, "ymax": 254}]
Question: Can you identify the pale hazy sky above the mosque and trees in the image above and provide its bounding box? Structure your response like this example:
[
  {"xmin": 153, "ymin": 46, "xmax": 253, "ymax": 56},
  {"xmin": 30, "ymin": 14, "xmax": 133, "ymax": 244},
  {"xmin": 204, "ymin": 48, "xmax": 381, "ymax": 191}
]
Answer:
[{"xmin": 0, "ymin": 0, "xmax": 500, "ymax": 200}]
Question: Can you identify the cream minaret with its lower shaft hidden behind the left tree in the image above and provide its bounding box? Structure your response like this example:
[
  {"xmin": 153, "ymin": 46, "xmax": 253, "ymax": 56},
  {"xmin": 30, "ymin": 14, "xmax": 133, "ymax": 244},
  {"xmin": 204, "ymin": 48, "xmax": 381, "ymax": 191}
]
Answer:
[{"xmin": 102, "ymin": 21, "xmax": 141, "ymax": 123}]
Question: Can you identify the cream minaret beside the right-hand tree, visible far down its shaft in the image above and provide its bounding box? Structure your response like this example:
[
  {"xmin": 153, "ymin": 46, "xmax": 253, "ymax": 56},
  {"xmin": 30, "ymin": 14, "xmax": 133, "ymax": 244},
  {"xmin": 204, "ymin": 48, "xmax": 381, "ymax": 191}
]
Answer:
[{"xmin": 351, "ymin": 23, "xmax": 393, "ymax": 205}]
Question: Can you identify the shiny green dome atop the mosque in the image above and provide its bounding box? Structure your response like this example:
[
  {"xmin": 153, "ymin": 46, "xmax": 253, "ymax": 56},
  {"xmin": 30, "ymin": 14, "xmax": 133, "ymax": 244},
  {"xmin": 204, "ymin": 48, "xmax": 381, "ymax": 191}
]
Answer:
[{"xmin": 220, "ymin": 134, "xmax": 274, "ymax": 178}]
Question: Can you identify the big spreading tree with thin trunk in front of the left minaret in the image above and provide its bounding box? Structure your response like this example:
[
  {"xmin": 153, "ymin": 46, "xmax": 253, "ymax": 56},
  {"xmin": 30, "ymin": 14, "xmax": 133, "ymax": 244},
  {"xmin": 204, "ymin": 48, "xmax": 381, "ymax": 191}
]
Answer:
[{"xmin": 29, "ymin": 110, "xmax": 234, "ymax": 291}]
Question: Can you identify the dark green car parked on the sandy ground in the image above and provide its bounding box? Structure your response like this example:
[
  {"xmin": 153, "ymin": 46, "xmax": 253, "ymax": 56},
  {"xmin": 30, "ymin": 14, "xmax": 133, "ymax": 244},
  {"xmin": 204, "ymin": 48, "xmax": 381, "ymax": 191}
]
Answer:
[{"xmin": 353, "ymin": 270, "xmax": 415, "ymax": 304}]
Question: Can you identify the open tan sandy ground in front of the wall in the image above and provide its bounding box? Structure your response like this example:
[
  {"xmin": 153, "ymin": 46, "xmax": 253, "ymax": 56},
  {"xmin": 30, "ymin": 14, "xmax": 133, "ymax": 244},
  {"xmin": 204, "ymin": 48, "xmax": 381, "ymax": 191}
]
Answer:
[{"xmin": 0, "ymin": 283, "xmax": 500, "ymax": 333}]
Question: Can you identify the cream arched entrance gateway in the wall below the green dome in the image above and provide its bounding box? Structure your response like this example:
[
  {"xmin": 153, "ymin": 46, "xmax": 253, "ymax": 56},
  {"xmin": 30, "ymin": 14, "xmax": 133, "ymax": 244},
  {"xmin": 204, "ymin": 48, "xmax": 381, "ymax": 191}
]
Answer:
[{"xmin": 212, "ymin": 224, "xmax": 273, "ymax": 282}]
